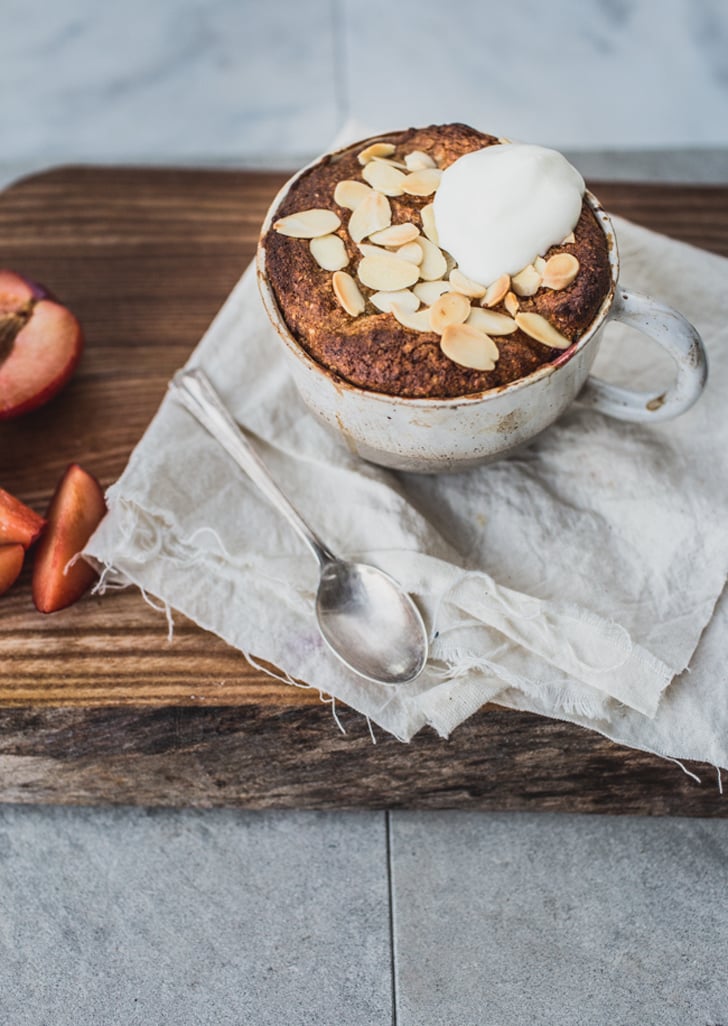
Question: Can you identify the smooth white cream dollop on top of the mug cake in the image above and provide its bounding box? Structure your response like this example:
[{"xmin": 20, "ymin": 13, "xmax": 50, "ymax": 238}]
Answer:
[{"xmin": 435, "ymin": 143, "xmax": 584, "ymax": 285}]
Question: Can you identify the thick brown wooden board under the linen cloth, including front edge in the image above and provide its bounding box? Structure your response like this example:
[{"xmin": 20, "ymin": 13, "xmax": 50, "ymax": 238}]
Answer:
[{"xmin": 0, "ymin": 167, "xmax": 728, "ymax": 816}]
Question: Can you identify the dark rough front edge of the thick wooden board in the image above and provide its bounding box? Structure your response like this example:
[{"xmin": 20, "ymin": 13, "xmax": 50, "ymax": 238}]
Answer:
[{"xmin": 0, "ymin": 707, "xmax": 728, "ymax": 817}]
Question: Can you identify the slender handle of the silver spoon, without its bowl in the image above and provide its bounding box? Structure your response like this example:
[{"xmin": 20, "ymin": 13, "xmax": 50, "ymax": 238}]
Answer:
[{"xmin": 169, "ymin": 367, "xmax": 336, "ymax": 567}]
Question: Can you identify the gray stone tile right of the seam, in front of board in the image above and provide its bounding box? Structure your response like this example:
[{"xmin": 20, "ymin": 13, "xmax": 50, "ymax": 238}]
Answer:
[{"xmin": 391, "ymin": 812, "xmax": 728, "ymax": 1026}]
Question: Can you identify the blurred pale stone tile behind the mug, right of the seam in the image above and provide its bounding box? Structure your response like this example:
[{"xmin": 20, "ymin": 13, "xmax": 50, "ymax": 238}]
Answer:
[{"xmin": 343, "ymin": 0, "xmax": 728, "ymax": 149}]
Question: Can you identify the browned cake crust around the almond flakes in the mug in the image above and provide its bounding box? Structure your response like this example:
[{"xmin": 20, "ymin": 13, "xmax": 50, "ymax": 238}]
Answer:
[{"xmin": 265, "ymin": 124, "xmax": 610, "ymax": 398}]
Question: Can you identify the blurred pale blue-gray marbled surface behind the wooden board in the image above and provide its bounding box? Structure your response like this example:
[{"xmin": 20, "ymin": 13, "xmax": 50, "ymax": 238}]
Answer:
[{"xmin": 0, "ymin": 0, "xmax": 728, "ymax": 185}]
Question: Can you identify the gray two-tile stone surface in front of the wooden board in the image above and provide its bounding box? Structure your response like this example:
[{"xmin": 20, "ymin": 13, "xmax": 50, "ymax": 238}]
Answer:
[{"xmin": 0, "ymin": 806, "xmax": 728, "ymax": 1026}]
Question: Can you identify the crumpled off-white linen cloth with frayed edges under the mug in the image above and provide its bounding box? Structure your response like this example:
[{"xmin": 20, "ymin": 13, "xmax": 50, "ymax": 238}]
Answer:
[{"xmin": 86, "ymin": 219, "xmax": 728, "ymax": 766}]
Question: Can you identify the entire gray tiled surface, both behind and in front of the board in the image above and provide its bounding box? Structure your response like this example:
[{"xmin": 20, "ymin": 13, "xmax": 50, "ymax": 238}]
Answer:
[{"xmin": 0, "ymin": 0, "xmax": 728, "ymax": 1026}]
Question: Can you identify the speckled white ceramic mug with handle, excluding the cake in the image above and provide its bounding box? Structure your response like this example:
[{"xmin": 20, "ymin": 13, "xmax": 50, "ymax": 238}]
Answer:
[{"xmin": 257, "ymin": 159, "xmax": 707, "ymax": 473}]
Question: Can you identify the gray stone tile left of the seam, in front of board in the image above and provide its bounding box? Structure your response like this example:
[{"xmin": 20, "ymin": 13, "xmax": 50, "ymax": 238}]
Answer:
[{"xmin": 0, "ymin": 805, "xmax": 392, "ymax": 1026}]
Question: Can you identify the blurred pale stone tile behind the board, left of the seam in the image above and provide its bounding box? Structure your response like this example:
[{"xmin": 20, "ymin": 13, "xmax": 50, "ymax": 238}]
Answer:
[{"xmin": 0, "ymin": 0, "xmax": 342, "ymax": 164}]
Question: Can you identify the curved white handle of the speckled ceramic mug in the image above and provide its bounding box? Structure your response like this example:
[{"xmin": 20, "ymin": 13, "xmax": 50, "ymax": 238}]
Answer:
[{"xmin": 578, "ymin": 287, "xmax": 707, "ymax": 423}]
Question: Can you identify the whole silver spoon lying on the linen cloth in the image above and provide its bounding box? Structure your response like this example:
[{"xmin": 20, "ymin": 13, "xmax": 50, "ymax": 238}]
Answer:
[{"xmin": 169, "ymin": 367, "xmax": 428, "ymax": 684}]
